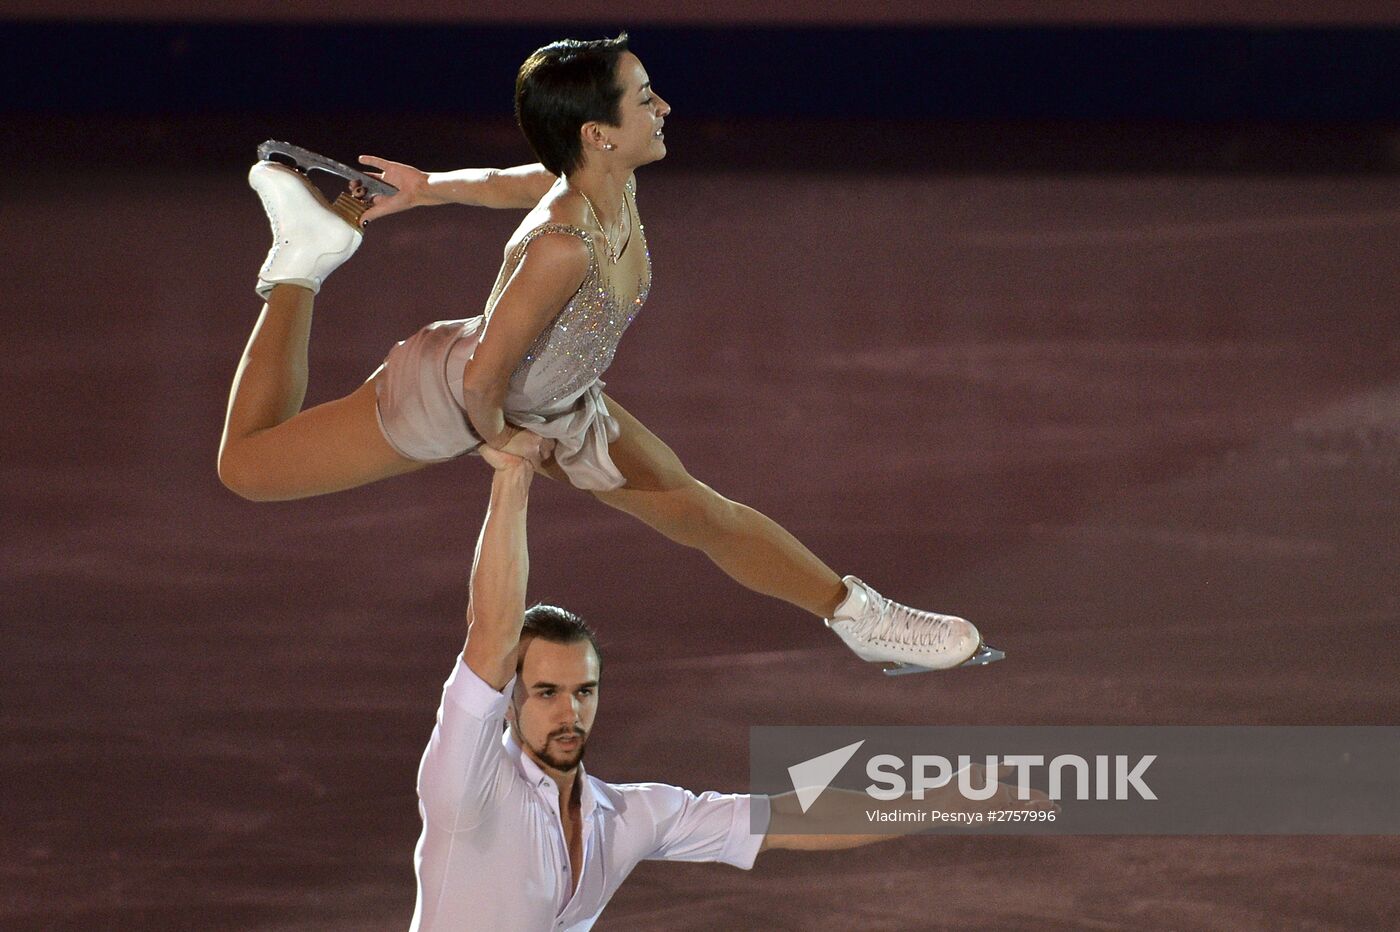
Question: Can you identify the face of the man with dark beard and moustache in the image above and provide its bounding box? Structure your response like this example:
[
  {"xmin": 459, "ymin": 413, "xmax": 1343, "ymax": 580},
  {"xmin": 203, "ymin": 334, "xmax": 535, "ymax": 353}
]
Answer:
[{"xmin": 508, "ymin": 638, "xmax": 598, "ymax": 774}]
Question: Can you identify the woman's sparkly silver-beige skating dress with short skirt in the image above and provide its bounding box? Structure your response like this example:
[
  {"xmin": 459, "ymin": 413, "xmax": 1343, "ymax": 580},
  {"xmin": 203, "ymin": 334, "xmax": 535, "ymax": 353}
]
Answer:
[{"xmin": 375, "ymin": 179, "xmax": 651, "ymax": 490}]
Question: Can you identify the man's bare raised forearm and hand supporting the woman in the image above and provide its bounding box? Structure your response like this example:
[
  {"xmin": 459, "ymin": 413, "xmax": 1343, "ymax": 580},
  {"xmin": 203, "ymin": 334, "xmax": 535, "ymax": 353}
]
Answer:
[{"xmin": 462, "ymin": 446, "xmax": 535, "ymax": 690}]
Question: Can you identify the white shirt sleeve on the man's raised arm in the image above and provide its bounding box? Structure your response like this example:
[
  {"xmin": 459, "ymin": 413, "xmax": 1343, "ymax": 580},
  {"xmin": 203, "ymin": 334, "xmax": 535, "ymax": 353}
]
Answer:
[{"xmin": 419, "ymin": 655, "xmax": 515, "ymax": 831}]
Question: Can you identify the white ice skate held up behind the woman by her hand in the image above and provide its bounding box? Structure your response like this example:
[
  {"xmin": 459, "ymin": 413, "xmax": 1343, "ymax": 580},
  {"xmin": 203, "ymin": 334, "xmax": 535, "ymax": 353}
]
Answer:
[{"xmin": 248, "ymin": 153, "xmax": 370, "ymax": 301}]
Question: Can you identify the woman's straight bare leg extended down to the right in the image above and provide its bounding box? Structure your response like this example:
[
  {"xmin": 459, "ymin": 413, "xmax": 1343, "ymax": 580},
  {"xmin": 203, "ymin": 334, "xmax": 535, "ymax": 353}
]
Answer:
[{"xmin": 595, "ymin": 397, "xmax": 846, "ymax": 619}]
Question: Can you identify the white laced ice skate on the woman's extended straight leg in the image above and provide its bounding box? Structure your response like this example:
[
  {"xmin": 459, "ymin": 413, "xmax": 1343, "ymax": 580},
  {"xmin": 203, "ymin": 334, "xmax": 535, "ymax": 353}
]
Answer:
[{"xmin": 826, "ymin": 577, "xmax": 1007, "ymax": 676}]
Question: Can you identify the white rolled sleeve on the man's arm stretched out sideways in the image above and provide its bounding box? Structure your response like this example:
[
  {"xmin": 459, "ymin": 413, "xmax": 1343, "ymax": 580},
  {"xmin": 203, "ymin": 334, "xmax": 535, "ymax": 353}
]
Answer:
[{"xmin": 629, "ymin": 784, "xmax": 769, "ymax": 870}]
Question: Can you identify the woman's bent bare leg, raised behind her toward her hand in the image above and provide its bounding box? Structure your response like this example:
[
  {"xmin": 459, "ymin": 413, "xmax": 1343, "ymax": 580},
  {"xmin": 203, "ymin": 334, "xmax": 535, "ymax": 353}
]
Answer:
[{"xmin": 218, "ymin": 284, "xmax": 423, "ymax": 501}]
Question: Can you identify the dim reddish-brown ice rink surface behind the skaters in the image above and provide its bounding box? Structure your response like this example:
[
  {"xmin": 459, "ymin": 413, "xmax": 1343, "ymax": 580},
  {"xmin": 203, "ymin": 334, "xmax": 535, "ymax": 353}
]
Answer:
[{"xmin": 0, "ymin": 139, "xmax": 1400, "ymax": 932}]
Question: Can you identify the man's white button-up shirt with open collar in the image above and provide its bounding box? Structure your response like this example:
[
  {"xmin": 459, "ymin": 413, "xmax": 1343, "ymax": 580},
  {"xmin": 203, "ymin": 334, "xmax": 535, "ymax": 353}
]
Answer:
[{"xmin": 412, "ymin": 656, "xmax": 769, "ymax": 932}]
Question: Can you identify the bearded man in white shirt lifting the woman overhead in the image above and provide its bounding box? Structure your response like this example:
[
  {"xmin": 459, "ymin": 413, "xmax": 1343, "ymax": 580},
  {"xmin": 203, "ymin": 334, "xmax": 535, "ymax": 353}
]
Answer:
[{"xmin": 412, "ymin": 438, "xmax": 1044, "ymax": 932}]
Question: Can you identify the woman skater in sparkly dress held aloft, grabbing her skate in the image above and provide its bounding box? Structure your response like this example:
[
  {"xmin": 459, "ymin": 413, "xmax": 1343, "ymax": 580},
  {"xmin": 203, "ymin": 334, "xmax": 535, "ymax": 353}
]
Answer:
[{"xmin": 218, "ymin": 34, "xmax": 1001, "ymax": 672}]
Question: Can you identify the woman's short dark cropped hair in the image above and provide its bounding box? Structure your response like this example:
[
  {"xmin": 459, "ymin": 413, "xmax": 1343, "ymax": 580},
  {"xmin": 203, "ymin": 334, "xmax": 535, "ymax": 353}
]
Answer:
[{"xmin": 515, "ymin": 32, "xmax": 627, "ymax": 175}]
